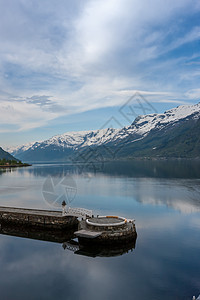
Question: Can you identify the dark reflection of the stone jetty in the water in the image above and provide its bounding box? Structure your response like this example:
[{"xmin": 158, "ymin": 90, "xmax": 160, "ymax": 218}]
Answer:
[{"xmin": 0, "ymin": 224, "xmax": 136, "ymax": 257}]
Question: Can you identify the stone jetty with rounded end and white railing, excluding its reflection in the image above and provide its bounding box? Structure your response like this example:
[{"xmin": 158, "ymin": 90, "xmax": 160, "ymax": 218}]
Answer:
[{"xmin": 0, "ymin": 206, "xmax": 137, "ymax": 246}]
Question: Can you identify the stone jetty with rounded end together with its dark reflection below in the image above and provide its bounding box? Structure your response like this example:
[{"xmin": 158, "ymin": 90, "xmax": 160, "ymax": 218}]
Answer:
[{"xmin": 0, "ymin": 205, "xmax": 137, "ymax": 257}]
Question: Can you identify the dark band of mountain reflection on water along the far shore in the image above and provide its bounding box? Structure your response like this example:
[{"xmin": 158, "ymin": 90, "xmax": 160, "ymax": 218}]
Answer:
[{"xmin": 16, "ymin": 160, "xmax": 200, "ymax": 179}]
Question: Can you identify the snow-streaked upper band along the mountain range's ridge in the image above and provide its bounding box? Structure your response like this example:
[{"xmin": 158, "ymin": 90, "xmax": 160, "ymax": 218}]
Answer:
[{"xmin": 7, "ymin": 103, "xmax": 200, "ymax": 155}]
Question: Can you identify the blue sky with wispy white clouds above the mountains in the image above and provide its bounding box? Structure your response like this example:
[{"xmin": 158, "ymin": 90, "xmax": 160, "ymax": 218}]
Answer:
[{"xmin": 0, "ymin": 0, "xmax": 200, "ymax": 148}]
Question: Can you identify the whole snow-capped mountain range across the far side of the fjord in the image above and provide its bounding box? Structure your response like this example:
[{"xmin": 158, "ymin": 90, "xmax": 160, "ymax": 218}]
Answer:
[{"xmin": 6, "ymin": 103, "xmax": 200, "ymax": 162}]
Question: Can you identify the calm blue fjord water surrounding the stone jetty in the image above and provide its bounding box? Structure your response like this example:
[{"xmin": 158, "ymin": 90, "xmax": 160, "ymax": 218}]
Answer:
[{"xmin": 0, "ymin": 161, "xmax": 200, "ymax": 300}]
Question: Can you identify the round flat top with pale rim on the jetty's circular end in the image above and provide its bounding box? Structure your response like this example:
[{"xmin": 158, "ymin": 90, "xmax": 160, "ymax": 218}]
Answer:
[{"xmin": 86, "ymin": 216, "xmax": 127, "ymax": 228}]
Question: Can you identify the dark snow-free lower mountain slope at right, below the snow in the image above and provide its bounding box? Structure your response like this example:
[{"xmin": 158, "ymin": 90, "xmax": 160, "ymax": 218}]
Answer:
[{"xmin": 116, "ymin": 119, "xmax": 200, "ymax": 158}]
